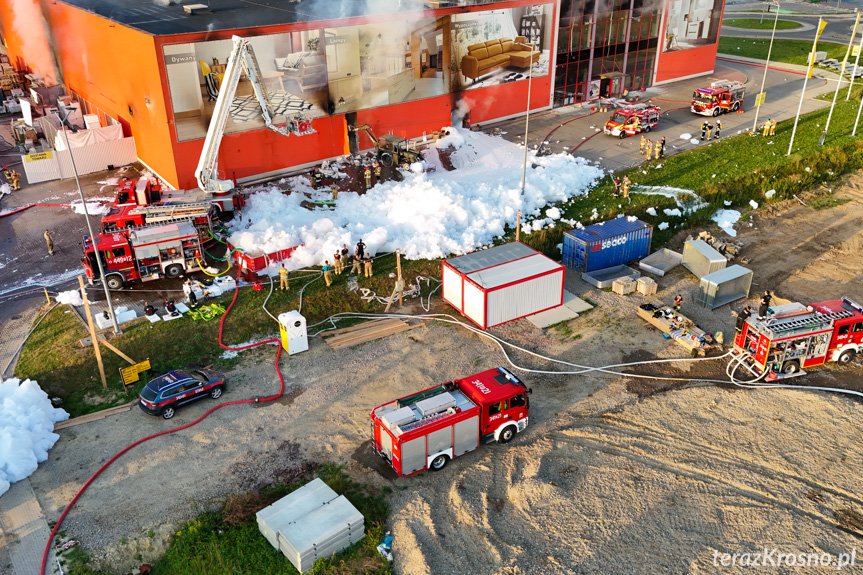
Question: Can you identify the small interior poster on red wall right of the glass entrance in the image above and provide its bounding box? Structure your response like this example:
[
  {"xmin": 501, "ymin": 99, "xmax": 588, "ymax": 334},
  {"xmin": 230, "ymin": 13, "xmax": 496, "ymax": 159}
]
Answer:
[{"xmin": 662, "ymin": 0, "xmax": 723, "ymax": 52}]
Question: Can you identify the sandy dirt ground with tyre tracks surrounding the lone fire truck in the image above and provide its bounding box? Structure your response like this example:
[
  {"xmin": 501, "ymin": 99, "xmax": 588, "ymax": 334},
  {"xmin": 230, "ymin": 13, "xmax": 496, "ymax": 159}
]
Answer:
[{"xmin": 23, "ymin": 177, "xmax": 863, "ymax": 575}]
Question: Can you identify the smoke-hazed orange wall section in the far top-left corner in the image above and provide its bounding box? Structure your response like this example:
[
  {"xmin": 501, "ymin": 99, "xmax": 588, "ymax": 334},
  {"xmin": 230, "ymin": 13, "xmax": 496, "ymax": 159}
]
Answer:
[{"xmin": 0, "ymin": 0, "xmax": 58, "ymax": 86}]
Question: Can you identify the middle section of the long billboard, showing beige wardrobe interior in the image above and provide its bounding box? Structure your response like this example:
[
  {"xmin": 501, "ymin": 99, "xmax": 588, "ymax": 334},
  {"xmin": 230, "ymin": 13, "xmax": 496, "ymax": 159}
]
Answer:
[{"xmin": 324, "ymin": 17, "xmax": 449, "ymax": 114}]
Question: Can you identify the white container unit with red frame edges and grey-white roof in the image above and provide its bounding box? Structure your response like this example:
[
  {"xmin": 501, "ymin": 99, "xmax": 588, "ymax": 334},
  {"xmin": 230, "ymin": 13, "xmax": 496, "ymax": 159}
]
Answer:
[{"xmin": 443, "ymin": 242, "xmax": 564, "ymax": 329}]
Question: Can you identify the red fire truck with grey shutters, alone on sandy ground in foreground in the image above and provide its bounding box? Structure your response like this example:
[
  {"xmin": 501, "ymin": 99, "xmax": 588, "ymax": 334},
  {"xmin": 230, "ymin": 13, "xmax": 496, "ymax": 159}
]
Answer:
[{"xmin": 371, "ymin": 367, "xmax": 532, "ymax": 477}]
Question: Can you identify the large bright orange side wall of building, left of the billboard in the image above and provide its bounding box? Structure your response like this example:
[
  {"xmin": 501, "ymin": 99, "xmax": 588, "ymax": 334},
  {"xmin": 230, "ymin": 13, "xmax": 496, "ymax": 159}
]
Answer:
[{"xmin": 47, "ymin": 2, "xmax": 177, "ymax": 185}]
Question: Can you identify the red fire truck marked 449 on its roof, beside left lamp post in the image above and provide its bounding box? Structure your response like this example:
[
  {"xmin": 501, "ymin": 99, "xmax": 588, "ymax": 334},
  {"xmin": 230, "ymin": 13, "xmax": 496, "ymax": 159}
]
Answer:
[{"xmin": 81, "ymin": 222, "xmax": 202, "ymax": 289}]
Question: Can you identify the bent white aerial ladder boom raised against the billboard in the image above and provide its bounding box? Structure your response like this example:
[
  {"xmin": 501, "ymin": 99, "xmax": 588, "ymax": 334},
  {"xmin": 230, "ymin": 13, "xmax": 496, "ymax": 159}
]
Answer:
[{"xmin": 195, "ymin": 36, "xmax": 293, "ymax": 195}]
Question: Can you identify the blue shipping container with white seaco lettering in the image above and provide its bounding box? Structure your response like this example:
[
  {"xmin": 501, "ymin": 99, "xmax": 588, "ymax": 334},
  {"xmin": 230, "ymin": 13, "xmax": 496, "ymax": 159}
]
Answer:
[{"xmin": 563, "ymin": 218, "xmax": 653, "ymax": 272}]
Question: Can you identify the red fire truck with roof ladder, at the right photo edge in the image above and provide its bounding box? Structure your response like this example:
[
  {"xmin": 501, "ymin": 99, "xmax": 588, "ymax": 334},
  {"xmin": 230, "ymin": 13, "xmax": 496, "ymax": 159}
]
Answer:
[{"xmin": 734, "ymin": 298, "xmax": 863, "ymax": 379}]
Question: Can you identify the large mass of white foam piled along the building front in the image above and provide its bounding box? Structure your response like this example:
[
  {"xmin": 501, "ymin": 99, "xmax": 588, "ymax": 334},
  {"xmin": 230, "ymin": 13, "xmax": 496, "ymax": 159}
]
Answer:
[{"xmin": 230, "ymin": 126, "xmax": 604, "ymax": 269}]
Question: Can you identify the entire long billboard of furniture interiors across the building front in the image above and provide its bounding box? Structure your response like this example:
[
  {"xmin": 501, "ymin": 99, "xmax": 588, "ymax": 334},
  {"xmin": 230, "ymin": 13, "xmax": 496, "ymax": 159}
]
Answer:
[{"xmin": 163, "ymin": 3, "xmax": 554, "ymax": 141}]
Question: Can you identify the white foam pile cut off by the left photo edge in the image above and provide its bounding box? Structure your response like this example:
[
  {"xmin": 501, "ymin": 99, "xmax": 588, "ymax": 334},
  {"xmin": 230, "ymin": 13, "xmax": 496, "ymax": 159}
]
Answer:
[{"xmin": 0, "ymin": 378, "xmax": 69, "ymax": 495}]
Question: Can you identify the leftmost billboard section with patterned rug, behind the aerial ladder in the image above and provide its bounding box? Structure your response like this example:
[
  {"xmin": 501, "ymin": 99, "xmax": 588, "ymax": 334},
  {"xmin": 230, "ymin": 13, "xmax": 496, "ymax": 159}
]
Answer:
[{"xmin": 163, "ymin": 30, "xmax": 328, "ymax": 142}]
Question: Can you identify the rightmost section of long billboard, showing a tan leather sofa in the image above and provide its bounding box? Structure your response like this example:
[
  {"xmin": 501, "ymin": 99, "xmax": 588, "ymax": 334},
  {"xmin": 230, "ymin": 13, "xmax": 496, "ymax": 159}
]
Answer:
[{"xmin": 450, "ymin": 4, "xmax": 554, "ymax": 90}]
